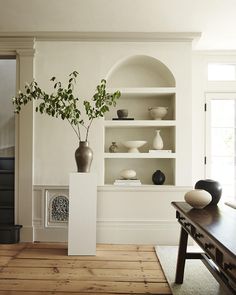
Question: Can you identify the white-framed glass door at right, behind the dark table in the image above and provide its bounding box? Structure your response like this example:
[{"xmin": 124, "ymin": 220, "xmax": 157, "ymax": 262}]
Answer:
[{"xmin": 206, "ymin": 93, "xmax": 236, "ymax": 200}]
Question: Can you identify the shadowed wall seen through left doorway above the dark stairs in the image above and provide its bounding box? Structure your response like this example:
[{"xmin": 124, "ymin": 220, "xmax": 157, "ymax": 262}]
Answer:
[{"xmin": 0, "ymin": 59, "xmax": 16, "ymax": 155}]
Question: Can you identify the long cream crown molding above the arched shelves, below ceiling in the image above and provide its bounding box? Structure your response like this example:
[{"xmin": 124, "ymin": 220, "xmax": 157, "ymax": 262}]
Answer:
[{"xmin": 0, "ymin": 31, "xmax": 201, "ymax": 42}]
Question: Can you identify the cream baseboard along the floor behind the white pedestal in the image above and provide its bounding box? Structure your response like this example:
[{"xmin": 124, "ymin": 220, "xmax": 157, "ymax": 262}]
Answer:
[{"xmin": 34, "ymin": 219, "xmax": 180, "ymax": 245}]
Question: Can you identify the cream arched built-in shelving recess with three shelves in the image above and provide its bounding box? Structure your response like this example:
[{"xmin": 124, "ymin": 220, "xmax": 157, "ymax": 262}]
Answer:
[{"xmin": 104, "ymin": 56, "xmax": 177, "ymax": 185}]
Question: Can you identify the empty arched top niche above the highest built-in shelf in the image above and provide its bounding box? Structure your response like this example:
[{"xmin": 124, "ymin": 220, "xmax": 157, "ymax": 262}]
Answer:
[{"xmin": 107, "ymin": 55, "xmax": 175, "ymax": 87}]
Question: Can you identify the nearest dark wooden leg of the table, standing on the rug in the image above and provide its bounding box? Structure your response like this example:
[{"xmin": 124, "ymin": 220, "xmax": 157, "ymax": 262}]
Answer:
[{"xmin": 175, "ymin": 227, "xmax": 188, "ymax": 284}]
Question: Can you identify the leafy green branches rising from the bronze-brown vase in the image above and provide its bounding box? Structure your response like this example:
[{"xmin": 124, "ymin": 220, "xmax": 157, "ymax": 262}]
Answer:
[{"xmin": 12, "ymin": 71, "xmax": 121, "ymax": 141}]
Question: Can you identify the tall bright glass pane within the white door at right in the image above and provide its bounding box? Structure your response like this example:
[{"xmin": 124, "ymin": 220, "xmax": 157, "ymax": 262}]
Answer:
[{"xmin": 209, "ymin": 99, "xmax": 236, "ymax": 199}]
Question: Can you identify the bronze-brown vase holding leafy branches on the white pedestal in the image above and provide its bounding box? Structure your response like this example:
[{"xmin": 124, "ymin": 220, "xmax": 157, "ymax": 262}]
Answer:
[{"xmin": 75, "ymin": 141, "xmax": 93, "ymax": 173}]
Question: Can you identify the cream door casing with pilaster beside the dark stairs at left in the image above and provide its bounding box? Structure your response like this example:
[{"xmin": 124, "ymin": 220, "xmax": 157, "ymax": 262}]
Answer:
[{"xmin": 0, "ymin": 37, "xmax": 35, "ymax": 242}]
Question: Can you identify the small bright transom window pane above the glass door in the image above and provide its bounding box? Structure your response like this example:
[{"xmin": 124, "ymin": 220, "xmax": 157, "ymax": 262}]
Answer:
[{"xmin": 208, "ymin": 63, "xmax": 236, "ymax": 81}]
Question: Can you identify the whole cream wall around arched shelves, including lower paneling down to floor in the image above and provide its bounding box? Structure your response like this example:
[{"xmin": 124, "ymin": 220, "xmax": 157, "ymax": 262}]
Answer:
[{"xmin": 29, "ymin": 41, "xmax": 192, "ymax": 244}]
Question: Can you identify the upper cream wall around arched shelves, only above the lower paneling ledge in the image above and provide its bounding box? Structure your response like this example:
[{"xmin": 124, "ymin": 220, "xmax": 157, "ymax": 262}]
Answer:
[{"xmin": 34, "ymin": 42, "xmax": 192, "ymax": 186}]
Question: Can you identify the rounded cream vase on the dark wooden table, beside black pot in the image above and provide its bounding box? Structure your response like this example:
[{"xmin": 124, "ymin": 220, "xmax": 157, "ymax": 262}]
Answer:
[{"xmin": 184, "ymin": 189, "xmax": 212, "ymax": 209}]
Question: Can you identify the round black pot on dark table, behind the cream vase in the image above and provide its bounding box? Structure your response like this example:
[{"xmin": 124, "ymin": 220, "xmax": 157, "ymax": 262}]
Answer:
[{"xmin": 195, "ymin": 179, "xmax": 222, "ymax": 206}]
